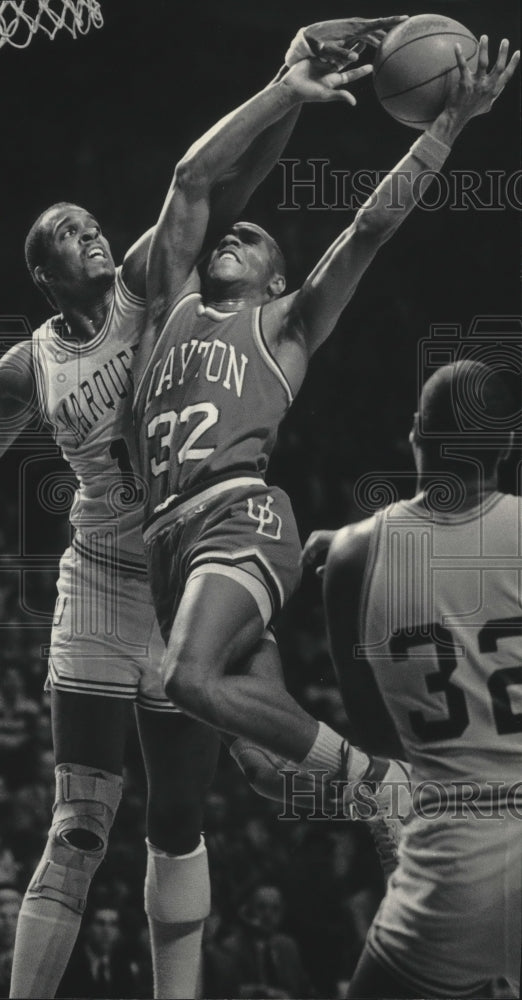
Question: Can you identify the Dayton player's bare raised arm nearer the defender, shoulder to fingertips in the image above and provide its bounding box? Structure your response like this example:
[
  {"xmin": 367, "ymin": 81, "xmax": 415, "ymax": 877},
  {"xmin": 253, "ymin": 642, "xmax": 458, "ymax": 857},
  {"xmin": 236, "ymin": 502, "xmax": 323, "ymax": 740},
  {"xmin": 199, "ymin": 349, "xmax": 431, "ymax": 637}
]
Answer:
[{"xmin": 147, "ymin": 56, "xmax": 371, "ymax": 315}]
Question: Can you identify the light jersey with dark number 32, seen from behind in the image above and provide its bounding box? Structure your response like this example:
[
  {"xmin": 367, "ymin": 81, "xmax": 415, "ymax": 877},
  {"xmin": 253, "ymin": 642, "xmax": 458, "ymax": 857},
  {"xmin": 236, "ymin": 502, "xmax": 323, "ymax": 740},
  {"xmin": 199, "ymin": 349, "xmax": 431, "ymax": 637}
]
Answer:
[{"xmin": 359, "ymin": 493, "xmax": 522, "ymax": 788}]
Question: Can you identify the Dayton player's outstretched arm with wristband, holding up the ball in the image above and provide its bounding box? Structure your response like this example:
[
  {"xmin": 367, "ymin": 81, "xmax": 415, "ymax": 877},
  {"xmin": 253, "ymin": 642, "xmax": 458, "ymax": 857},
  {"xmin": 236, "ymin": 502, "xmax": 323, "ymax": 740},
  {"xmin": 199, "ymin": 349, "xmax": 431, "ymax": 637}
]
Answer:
[{"xmin": 264, "ymin": 36, "xmax": 520, "ymax": 364}]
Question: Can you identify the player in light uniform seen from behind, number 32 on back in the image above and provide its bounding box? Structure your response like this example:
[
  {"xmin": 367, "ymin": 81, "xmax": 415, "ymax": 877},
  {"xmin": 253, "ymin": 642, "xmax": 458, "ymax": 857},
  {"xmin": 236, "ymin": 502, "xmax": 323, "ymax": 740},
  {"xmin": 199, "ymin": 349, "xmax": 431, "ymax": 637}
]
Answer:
[{"xmin": 325, "ymin": 361, "xmax": 522, "ymax": 998}]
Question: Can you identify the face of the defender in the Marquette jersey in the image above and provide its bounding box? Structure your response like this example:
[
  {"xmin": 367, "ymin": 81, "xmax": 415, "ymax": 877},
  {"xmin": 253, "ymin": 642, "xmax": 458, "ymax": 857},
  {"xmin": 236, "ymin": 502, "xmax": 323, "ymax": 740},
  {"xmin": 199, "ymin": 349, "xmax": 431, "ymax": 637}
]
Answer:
[{"xmin": 44, "ymin": 205, "xmax": 115, "ymax": 292}]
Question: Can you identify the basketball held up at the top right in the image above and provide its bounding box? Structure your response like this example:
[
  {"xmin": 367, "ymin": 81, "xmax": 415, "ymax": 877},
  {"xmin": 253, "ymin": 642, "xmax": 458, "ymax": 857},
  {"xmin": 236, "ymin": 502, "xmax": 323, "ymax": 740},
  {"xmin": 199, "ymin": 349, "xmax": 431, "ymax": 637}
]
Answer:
[{"xmin": 373, "ymin": 14, "xmax": 478, "ymax": 130}]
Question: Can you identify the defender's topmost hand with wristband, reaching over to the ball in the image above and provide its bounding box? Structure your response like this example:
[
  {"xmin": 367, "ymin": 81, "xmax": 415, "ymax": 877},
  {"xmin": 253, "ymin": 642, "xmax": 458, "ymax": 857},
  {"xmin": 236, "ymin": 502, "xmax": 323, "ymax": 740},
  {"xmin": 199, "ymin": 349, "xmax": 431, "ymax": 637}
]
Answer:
[{"xmin": 285, "ymin": 14, "xmax": 408, "ymax": 69}]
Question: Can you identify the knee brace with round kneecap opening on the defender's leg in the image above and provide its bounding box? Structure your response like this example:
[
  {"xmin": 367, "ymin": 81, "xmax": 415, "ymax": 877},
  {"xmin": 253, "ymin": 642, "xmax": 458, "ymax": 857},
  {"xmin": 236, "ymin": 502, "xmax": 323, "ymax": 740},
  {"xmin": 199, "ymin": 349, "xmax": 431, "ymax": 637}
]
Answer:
[{"xmin": 27, "ymin": 764, "xmax": 123, "ymax": 913}]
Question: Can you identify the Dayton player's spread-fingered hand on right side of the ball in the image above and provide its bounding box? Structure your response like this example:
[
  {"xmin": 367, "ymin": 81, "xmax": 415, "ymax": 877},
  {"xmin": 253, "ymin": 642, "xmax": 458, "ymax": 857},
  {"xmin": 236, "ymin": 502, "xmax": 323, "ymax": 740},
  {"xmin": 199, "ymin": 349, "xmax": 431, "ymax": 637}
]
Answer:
[{"xmin": 445, "ymin": 35, "xmax": 520, "ymax": 124}]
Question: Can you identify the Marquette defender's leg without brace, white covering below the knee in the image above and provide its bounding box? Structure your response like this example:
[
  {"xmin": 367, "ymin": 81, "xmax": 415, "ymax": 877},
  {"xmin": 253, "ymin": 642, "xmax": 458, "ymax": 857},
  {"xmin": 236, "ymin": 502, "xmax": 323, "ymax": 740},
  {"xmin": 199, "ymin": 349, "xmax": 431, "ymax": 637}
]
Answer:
[{"xmin": 137, "ymin": 707, "xmax": 220, "ymax": 1000}]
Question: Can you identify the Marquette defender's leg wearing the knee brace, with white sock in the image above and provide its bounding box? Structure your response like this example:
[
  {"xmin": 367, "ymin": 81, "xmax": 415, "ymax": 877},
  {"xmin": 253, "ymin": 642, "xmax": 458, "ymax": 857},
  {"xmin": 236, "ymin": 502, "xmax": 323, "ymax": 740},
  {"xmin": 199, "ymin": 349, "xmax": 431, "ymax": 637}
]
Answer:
[{"xmin": 10, "ymin": 689, "xmax": 129, "ymax": 1000}]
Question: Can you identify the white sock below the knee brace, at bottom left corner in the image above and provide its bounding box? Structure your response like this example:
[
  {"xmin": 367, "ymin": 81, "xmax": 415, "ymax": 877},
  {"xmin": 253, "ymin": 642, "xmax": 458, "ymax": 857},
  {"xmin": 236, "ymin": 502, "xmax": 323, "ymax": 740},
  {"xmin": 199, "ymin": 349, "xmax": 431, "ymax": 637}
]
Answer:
[{"xmin": 9, "ymin": 897, "xmax": 82, "ymax": 1000}]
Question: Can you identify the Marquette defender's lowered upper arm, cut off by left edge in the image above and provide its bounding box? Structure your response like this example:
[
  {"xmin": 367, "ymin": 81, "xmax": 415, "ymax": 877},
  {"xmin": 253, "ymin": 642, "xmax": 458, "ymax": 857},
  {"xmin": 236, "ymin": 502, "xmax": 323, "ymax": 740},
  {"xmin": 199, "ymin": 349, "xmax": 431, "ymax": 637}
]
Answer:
[{"xmin": 0, "ymin": 340, "xmax": 38, "ymax": 456}]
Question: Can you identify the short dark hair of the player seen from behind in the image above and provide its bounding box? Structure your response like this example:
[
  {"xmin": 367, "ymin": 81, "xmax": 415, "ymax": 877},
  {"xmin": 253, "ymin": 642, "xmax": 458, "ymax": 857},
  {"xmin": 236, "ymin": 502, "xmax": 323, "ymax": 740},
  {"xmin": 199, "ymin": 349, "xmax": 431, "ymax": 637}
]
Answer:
[{"xmin": 416, "ymin": 359, "xmax": 515, "ymax": 470}]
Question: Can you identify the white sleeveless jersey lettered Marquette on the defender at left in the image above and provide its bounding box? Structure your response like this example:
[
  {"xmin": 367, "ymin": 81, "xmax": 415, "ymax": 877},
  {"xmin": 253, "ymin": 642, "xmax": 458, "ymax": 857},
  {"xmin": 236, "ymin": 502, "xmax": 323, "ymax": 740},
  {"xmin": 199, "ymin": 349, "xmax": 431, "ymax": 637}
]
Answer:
[{"xmin": 33, "ymin": 268, "xmax": 145, "ymax": 569}]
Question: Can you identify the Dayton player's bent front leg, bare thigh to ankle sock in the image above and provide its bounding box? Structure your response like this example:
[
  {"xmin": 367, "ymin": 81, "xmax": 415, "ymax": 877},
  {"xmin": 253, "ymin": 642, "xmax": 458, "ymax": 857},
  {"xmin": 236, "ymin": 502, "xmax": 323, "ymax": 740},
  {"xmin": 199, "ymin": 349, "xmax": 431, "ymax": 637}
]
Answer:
[{"xmin": 163, "ymin": 566, "xmax": 368, "ymax": 780}]
